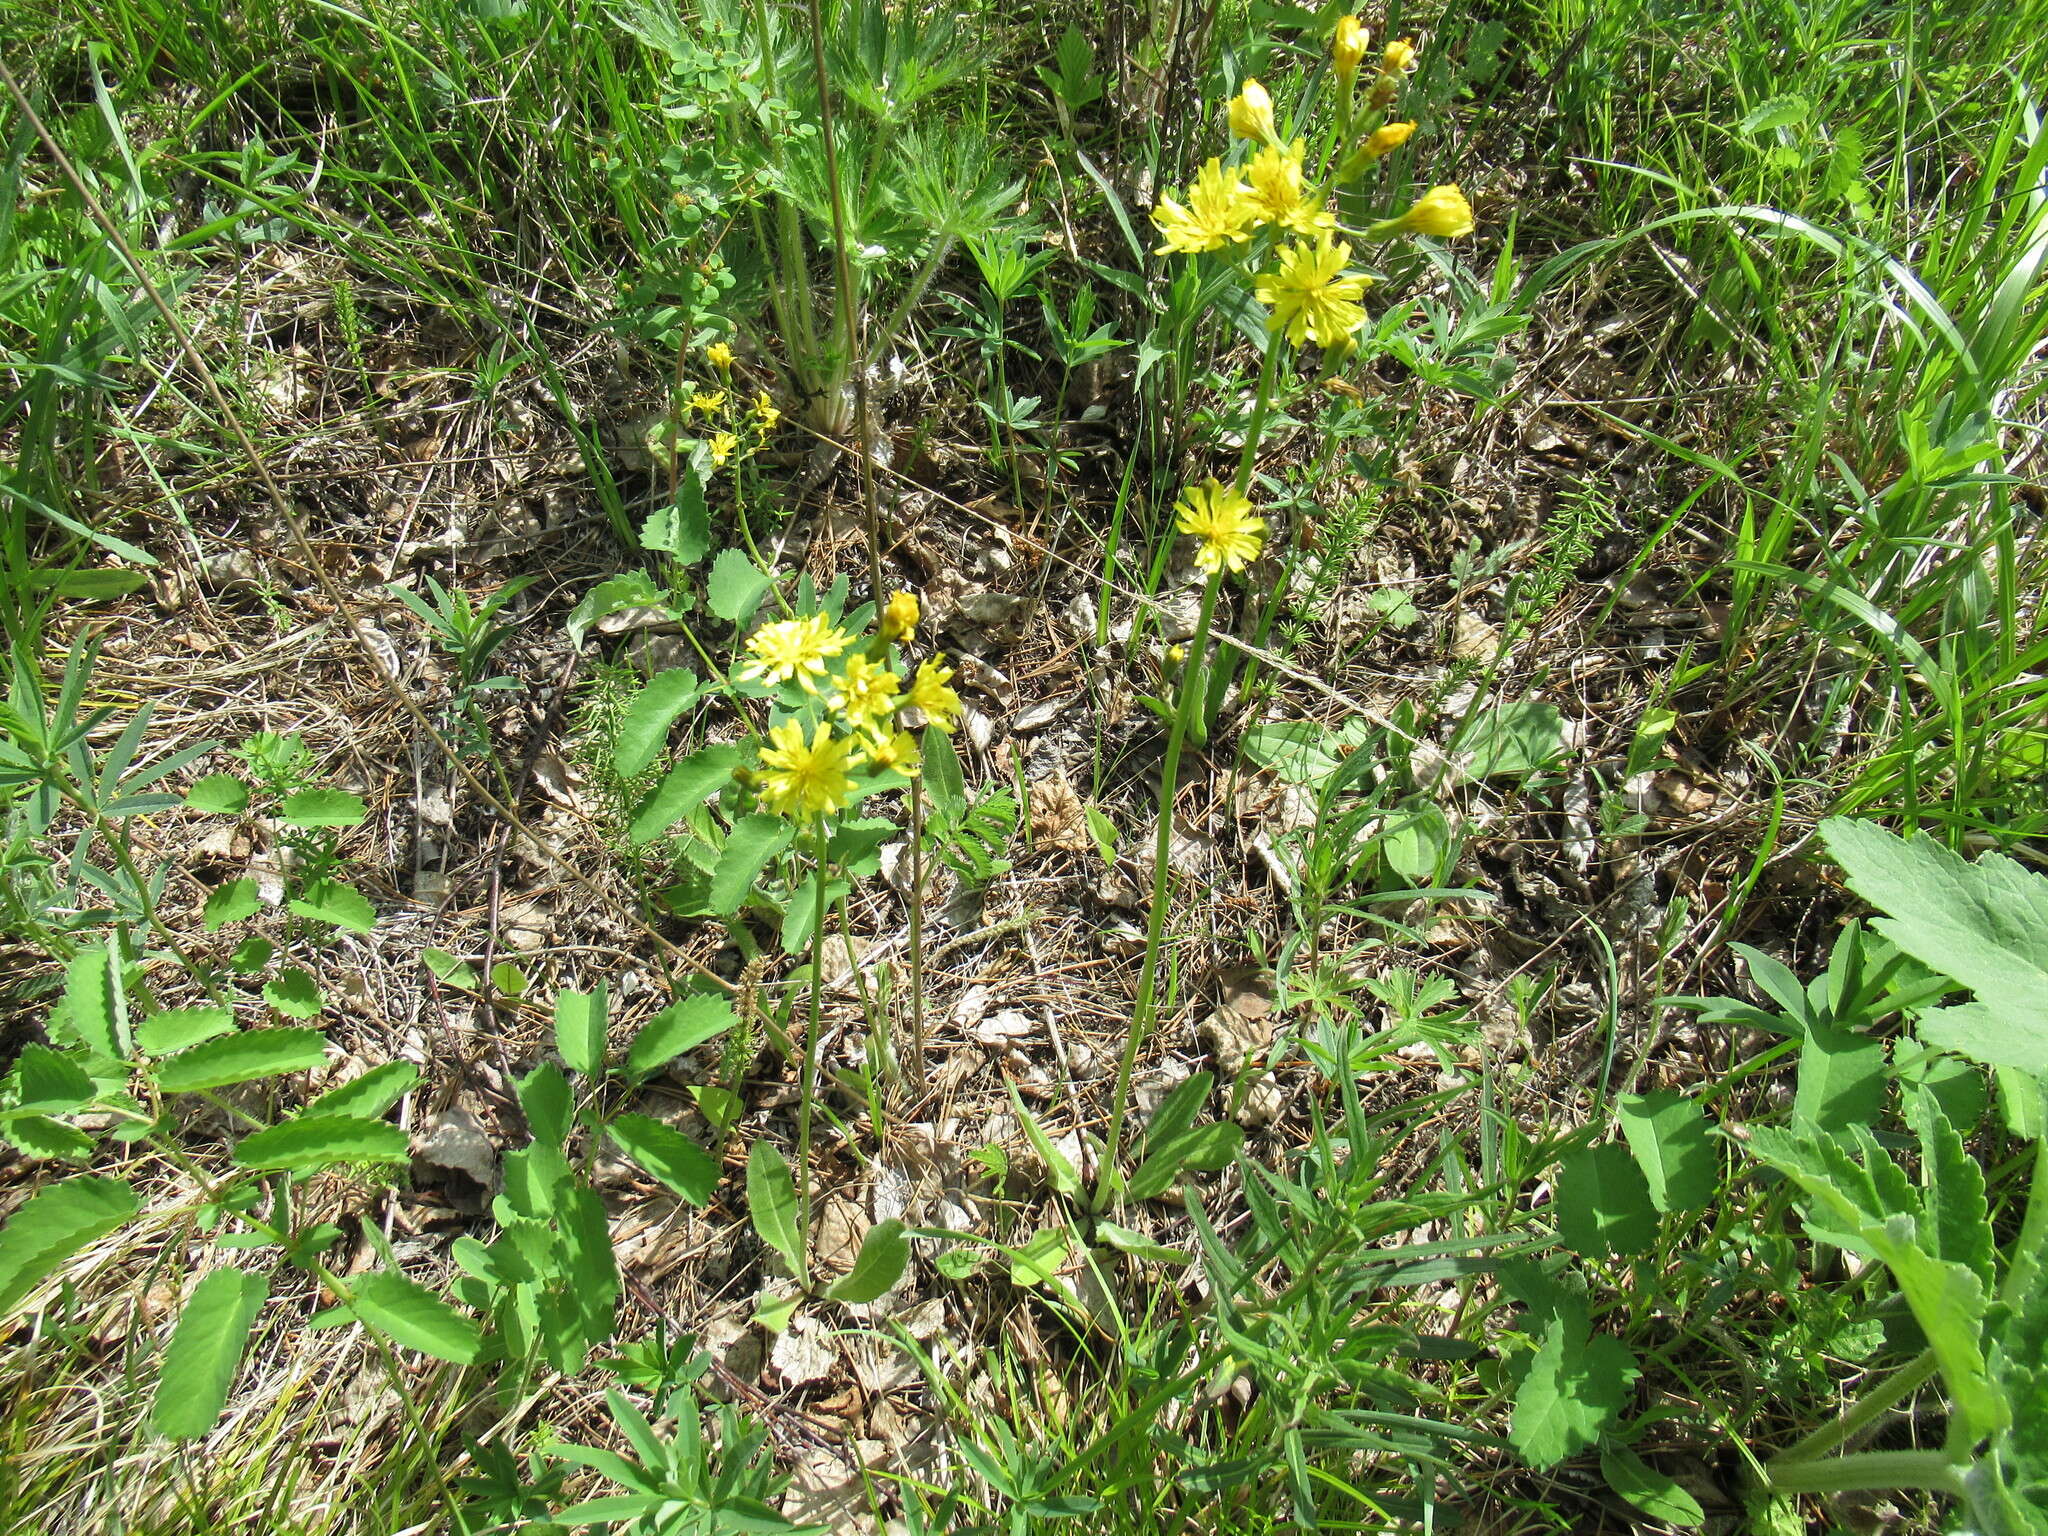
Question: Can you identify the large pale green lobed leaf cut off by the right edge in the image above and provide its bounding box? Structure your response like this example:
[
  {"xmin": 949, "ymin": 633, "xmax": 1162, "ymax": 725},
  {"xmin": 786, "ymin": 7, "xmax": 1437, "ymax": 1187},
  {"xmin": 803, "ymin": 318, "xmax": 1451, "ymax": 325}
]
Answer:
[{"xmin": 1821, "ymin": 817, "xmax": 2048, "ymax": 1075}]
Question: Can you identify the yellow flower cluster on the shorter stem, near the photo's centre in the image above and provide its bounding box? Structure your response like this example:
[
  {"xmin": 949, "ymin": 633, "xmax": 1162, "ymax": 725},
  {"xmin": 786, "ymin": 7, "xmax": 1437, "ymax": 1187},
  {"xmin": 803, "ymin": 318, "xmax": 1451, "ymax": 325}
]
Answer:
[{"xmin": 739, "ymin": 592, "xmax": 963, "ymax": 821}]
